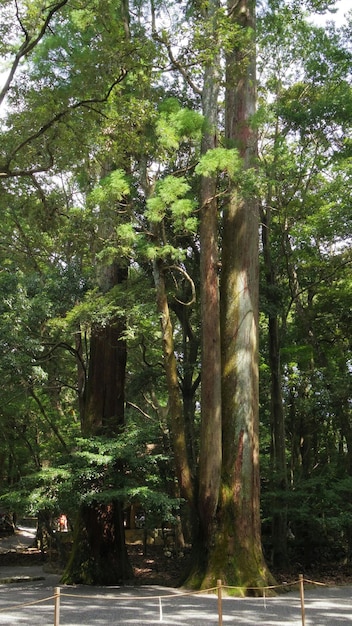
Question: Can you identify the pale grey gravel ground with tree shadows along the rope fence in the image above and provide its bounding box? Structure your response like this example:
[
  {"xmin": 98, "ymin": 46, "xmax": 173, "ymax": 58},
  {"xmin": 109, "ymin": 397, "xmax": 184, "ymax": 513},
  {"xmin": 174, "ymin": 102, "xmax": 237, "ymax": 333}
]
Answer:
[{"xmin": 0, "ymin": 531, "xmax": 352, "ymax": 626}]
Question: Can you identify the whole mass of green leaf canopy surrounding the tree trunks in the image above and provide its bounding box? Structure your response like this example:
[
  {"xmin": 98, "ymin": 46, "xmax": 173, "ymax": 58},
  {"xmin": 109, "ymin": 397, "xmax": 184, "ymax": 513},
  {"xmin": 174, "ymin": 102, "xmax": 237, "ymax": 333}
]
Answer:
[{"xmin": 0, "ymin": 0, "xmax": 352, "ymax": 580}]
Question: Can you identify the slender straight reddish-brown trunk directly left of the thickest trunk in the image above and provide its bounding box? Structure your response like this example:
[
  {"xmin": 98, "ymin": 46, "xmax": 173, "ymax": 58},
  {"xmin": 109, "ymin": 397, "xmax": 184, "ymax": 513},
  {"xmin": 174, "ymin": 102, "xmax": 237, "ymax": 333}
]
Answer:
[{"xmin": 198, "ymin": 0, "xmax": 222, "ymax": 550}]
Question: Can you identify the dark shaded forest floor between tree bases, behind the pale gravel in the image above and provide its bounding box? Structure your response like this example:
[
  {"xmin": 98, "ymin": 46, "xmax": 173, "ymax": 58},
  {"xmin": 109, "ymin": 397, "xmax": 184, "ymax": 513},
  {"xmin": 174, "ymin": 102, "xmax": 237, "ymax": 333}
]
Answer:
[{"xmin": 0, "ymin": 531, "xmax": 352, "ymax": 587}]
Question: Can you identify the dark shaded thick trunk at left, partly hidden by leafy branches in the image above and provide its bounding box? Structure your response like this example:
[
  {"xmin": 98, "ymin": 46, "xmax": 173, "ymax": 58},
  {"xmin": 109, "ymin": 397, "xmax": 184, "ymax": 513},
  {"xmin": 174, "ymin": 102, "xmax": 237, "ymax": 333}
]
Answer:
[{"xmin": 62, "ymin": 264, "xmax": 132, "ymax": 585}]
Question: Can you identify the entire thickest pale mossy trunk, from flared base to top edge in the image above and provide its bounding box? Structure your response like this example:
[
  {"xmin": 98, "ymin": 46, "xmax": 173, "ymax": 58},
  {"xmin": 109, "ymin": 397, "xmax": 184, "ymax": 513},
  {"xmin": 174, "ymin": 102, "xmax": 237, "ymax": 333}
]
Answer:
[{"xmin": 203, "ymin": 0, "xmax": 270, "ymax": 593}]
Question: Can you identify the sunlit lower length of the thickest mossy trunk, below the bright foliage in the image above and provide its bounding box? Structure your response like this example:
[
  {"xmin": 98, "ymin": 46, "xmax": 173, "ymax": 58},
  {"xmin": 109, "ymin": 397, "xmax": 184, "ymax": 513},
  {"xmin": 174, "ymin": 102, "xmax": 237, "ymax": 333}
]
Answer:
[{"xmin": 215, "ymin": 184, "xmax": 268, "ymax": 586}]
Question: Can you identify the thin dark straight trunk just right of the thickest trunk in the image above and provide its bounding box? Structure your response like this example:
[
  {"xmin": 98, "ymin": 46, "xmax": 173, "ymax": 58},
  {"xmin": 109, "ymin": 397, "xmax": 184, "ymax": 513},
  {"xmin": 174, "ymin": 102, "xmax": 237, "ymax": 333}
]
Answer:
[{"xmin": 261, "ymin": 204, "xmax": 288, "ymax": 567}]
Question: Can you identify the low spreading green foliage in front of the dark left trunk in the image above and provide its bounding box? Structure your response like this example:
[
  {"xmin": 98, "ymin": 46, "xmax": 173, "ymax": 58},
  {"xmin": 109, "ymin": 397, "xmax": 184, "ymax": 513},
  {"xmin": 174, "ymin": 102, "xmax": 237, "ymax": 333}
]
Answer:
[{"xmin": 0, "ymin": 422, "xmax": 180, "ymax": 524}]
